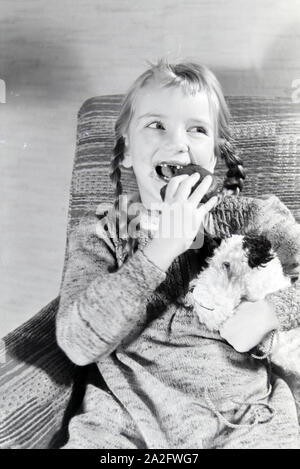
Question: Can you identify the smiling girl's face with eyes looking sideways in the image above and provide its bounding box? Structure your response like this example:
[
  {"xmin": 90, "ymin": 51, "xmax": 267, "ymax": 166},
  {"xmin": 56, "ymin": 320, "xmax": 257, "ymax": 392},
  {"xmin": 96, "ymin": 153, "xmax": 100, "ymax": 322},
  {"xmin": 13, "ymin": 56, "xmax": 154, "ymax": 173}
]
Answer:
[{"xmin": 122, "ymin": 84, "xmax": 216, "ymax": 209}]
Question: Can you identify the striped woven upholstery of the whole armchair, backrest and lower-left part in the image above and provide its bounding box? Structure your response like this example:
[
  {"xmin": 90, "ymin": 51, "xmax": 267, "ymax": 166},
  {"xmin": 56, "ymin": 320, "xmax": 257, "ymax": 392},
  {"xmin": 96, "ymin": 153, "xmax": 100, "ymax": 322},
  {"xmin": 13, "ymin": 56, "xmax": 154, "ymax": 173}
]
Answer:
[{"xmin": 0, "ymin": 95, "xmax": 300, "ymax": 448}]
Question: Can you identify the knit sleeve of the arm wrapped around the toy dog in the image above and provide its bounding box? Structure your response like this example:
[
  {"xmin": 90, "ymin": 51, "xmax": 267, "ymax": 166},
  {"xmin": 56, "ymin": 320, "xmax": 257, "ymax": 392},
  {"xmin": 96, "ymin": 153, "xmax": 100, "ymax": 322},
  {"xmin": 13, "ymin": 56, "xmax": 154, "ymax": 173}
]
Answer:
[{"xmin": 213, "ymin": 195, "xmax": 300, "ymax": 330}]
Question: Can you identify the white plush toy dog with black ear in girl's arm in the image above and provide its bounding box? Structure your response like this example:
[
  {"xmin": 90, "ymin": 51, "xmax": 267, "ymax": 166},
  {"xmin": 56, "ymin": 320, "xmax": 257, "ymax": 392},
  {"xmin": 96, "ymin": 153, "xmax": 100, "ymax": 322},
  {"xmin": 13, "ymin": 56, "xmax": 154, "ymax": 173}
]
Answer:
[{"xmin": 186, "ymin": 235, "xmax": 300, "ymax": 376}]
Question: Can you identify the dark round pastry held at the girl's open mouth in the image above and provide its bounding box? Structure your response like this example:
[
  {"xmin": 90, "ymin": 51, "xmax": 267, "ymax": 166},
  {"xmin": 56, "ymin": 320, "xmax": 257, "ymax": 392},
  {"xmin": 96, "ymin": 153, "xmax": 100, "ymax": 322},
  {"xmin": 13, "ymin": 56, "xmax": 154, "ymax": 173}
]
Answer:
[{"xmin": 155, "ymin": 163, "xmax": 222, "ymax": 203}]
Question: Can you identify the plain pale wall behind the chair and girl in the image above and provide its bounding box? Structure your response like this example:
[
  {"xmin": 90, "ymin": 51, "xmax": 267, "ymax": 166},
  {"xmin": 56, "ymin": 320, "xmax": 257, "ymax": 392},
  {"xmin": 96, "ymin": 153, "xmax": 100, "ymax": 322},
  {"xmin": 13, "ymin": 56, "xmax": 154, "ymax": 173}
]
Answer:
[{"xmin": 0, "ymin": 0, "xmax": 300, "ymax": 336}]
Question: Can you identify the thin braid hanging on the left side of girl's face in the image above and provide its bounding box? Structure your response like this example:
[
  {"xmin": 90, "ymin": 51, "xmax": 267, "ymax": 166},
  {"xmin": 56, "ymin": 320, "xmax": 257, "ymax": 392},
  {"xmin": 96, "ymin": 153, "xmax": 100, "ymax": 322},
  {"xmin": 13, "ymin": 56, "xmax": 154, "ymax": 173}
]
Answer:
[{"xmin": 109, "ymin": 137, "xmax": 137, "ymax": 257}]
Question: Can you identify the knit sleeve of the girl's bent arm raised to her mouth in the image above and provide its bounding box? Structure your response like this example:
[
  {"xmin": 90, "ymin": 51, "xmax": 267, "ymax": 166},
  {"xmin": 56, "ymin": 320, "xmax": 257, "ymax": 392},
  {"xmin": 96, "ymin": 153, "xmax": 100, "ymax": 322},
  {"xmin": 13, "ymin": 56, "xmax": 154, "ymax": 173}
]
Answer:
[{"xmin": 56, "ymin": 208, "xmax": 166, "ymax": 366}]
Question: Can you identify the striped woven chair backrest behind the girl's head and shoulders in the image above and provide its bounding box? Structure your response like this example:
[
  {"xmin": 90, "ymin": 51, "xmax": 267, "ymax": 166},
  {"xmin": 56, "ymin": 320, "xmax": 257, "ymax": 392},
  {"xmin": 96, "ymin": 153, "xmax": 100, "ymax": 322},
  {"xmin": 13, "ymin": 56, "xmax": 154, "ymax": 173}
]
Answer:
[{"xmin": 61, "ymin": 95, "xmax": 300, "ymax": 282}]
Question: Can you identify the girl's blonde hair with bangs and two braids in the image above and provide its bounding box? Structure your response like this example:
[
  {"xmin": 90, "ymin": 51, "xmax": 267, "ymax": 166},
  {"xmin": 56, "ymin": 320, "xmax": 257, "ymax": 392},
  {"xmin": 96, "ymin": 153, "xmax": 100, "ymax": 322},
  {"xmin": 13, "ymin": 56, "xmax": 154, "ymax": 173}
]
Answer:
[{"xmin": 110, "ymin": 59, "xmax": 244, "ymax": 258}]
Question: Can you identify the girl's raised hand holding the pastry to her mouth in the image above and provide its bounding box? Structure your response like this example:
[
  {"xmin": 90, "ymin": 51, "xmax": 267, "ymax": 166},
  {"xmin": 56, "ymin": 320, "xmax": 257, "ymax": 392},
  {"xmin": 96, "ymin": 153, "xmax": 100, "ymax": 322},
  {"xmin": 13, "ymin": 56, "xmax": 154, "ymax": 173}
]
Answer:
[{"xmin": 156, "ymin": 173, "xmax": 217, "ymax": 258}]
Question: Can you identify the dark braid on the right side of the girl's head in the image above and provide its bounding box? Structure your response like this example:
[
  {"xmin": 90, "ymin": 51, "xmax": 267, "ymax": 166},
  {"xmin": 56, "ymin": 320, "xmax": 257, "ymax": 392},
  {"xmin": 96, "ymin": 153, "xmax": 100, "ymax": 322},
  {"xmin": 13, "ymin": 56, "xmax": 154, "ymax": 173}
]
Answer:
[{"xmin": 220, "ymin": 139, "xmax": 246, "ymax": 195}]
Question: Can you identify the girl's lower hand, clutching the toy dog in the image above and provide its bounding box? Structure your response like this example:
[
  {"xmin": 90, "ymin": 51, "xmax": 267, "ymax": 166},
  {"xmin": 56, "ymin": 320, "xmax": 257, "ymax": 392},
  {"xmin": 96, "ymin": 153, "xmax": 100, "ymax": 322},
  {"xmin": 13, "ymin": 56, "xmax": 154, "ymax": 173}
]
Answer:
[{"xmin": 220, "ymin": 300, "xmax": 279, "ymax": 353}]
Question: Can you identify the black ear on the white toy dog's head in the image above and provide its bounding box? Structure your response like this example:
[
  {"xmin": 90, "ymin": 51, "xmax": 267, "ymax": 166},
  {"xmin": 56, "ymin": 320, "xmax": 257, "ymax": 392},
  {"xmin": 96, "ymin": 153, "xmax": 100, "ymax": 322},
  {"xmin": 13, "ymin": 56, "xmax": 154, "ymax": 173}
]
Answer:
[{"xmin": 243, "ymin": 235, "xmax": 274, "ymax": 269}]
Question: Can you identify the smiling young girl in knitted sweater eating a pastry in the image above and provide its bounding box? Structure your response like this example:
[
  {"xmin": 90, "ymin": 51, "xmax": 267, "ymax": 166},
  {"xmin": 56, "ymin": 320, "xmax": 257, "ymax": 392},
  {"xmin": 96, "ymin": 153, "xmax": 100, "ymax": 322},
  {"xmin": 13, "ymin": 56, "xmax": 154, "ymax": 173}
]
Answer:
[{"xmin": 57, "ymin": 61, "xmax": 300, "ymax": 449}]
